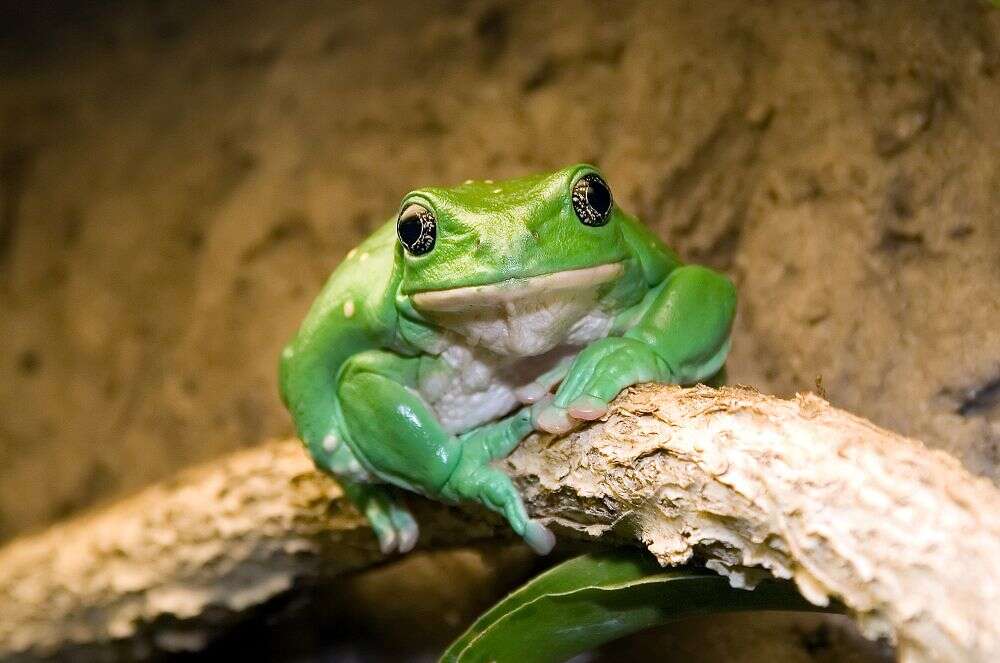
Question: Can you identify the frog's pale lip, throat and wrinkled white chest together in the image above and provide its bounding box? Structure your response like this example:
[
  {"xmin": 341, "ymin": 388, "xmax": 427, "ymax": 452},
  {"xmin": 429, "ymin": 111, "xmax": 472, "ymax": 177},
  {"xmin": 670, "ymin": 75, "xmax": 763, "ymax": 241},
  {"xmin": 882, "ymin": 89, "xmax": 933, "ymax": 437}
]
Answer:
[{"xmin": 413, "ymin": 263, "xmax": 624, "ymax": 433}]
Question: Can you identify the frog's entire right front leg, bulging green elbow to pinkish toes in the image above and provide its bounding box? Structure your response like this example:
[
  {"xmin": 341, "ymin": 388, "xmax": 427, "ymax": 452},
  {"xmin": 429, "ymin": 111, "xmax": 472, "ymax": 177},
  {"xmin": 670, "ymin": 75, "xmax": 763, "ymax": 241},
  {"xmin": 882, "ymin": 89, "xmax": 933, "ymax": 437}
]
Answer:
[{"xmin": 536, "ymin": 266, "xmax": 736, "ymax": 433}]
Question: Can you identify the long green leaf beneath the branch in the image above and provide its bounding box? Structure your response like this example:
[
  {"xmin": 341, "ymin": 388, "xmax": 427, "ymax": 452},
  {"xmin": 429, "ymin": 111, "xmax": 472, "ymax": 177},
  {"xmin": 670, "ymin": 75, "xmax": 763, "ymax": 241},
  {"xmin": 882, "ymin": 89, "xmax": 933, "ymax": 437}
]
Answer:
[{"xmin": 441, "ymin": 551, "xmax": 841, "ymax": 663}]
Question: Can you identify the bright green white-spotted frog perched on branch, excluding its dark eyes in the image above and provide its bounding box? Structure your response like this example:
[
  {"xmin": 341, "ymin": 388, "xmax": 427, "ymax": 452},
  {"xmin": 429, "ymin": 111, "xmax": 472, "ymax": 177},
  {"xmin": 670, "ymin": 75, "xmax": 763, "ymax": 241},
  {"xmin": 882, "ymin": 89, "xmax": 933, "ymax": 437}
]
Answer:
[{"xmin": 280, "ymin": 165, "xmax": 736, "ymax": 553}]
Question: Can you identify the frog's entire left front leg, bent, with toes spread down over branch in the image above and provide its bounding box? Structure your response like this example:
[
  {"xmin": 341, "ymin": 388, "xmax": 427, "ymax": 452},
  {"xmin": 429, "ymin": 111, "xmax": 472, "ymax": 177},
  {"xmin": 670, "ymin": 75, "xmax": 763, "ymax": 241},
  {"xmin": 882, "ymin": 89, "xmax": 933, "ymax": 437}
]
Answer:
[{"xmin": 337, "ymin": 351, "xmax": 554, "ymax": 552}]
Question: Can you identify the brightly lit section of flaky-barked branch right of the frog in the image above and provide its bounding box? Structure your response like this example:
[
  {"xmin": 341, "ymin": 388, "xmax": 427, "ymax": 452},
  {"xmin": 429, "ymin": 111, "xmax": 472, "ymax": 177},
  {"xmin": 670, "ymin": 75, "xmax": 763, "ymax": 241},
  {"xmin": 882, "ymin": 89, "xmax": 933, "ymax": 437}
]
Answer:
[{"xmin": 507, "ymin": 386, "xmax": 1000, "ymax": 661}]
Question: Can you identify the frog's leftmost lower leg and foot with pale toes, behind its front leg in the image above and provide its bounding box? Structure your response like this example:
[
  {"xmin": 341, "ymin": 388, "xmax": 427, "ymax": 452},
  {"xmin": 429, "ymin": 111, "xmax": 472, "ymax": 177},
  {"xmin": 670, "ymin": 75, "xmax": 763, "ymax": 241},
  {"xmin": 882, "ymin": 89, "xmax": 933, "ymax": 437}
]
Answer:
[{"xmin": 318, "ymin": 433, "xmax": 420, "ymax": 555}]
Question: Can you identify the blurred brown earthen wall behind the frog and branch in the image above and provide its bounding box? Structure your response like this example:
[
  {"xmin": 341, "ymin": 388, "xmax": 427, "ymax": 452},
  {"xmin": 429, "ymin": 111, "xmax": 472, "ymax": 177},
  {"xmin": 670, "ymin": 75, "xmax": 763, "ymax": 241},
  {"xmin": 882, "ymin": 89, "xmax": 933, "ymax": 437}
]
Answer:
[{"xmin": 0, "ymin": 0, "xmax": 1000, "ymax": 660}]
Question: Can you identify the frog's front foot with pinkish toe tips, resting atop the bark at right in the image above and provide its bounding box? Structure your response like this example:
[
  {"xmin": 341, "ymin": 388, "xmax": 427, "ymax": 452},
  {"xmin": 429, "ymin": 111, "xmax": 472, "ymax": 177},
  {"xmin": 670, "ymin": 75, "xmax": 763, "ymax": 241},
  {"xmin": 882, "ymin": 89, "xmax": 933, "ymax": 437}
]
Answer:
[{"xmin": 535, "ymin": 337, "xmax": 671, "ymax": 434}]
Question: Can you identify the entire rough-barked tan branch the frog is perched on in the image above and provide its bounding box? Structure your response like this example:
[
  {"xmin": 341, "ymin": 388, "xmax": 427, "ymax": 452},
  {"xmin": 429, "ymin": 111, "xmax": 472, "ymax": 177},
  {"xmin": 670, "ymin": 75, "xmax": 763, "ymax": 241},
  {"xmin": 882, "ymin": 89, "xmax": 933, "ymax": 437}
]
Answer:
[{"xmin": 0, "ymin": 385, "xmax": 1000, "ymax": 663}]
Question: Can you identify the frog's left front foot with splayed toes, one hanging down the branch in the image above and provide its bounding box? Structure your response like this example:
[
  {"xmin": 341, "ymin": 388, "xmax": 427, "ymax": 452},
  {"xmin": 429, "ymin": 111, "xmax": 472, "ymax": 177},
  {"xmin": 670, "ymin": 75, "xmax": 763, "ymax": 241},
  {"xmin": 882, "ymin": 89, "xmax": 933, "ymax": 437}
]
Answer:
[{"xmin": 441, "ymin": 416, "xmax": 556, "ymax": 555}]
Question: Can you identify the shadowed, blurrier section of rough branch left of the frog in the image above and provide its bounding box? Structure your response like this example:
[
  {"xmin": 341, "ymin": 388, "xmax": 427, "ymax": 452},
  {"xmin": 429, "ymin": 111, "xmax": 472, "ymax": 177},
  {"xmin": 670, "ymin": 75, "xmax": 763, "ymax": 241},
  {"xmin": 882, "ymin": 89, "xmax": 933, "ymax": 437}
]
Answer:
[{"xmin": 0, "ymin": 440, "xmax": 512, "ymax": 658}]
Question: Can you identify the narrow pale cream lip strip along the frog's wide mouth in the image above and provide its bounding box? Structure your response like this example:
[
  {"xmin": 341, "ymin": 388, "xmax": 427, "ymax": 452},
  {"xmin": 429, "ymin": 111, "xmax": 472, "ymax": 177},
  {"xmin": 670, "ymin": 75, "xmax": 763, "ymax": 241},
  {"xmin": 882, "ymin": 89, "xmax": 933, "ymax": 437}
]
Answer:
[{"xmin": 411, "ymin": 262, "xmax": 625, "ymax": 313}]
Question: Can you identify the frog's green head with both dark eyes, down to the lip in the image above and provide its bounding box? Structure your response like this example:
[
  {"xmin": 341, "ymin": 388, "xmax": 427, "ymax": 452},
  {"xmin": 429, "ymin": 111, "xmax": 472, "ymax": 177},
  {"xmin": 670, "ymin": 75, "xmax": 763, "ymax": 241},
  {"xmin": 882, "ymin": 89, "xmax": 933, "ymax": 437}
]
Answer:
[{"xmin": 396, "ymin": 164, "xmax": 627, "ymax": 311}]
